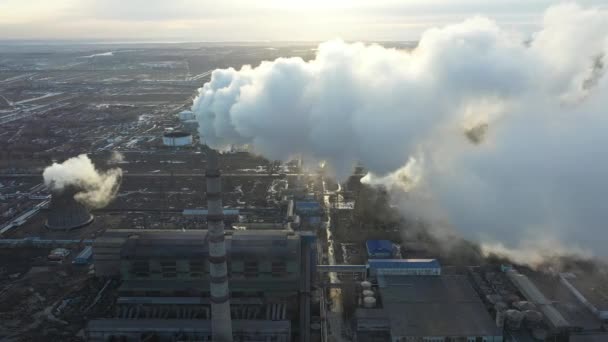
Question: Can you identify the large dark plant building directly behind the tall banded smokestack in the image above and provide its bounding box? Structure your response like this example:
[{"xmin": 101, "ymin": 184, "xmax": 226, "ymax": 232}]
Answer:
[{"xmin": 91, "ymin": 229, "xmax": 316, "ymax": 341}]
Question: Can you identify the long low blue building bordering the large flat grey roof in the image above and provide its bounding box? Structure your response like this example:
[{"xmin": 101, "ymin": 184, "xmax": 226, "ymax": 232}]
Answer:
[{"xmin": 368, "ymin": 259, "xmax": 441, "ymax": 278}]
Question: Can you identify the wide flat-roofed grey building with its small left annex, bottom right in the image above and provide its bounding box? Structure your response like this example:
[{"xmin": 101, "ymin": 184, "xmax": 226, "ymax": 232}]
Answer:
[{"xmin": 355, "ymin": 275, "xmax": 503, "ymax": 342}]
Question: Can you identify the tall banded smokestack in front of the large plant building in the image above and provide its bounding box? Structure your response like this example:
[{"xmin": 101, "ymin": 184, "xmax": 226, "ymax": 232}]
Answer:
[{"xmin": 205, "ymin": 150, "xmax": 232, "ymax": 342}]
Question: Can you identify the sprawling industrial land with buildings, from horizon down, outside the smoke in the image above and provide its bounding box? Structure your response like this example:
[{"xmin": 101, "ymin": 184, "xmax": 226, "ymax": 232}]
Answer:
[{"xmin": 0, "ymin": 43, "xmax": 608, "ymax": 342}]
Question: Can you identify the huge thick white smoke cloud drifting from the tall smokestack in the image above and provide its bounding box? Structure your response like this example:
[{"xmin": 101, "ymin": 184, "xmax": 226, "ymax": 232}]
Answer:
[{"xmin": 193, "ymin": 4, "xmax": 608, "ymax": 260}]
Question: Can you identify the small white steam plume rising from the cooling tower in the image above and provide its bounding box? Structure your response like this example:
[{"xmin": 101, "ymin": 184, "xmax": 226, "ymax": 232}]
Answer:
[{"xmin": 42, "ymin": 154, "xmax": 122, "ymax": 208}]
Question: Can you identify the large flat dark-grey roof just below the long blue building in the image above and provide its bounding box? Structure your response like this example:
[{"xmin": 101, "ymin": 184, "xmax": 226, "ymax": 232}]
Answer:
[{"xmin": 380, "ymin": 275, "xmax": 502, "ymax": 337}]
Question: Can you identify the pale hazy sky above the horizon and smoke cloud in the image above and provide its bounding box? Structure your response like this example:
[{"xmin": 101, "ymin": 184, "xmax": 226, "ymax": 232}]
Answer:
[{"xmin": 0, "ymin": 0, "xmax": 606, "ymax": 42}]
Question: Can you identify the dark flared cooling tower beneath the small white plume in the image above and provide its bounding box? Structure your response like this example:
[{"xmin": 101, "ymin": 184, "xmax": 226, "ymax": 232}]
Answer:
[{"xmin": 45, "ymin": 187, "xmax": 93, "ymax": 230}]
